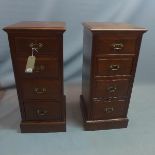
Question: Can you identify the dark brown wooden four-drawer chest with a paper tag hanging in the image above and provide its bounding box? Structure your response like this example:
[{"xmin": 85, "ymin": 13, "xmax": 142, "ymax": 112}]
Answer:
[{"xmin": 4, "ymin": 22, "xmax": 66, "ymax": 132}]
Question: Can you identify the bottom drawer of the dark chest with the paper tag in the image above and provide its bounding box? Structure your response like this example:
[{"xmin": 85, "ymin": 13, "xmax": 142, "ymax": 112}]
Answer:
[{"xmin": 24, "ymin": 101, "xmax": 61, "ymax": 121}]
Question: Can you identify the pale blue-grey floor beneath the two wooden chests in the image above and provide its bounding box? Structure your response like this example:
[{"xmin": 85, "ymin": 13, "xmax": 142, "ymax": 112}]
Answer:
[{"xmin": 0, "ymin": 84, "xmax": 155, "ymax": 155}]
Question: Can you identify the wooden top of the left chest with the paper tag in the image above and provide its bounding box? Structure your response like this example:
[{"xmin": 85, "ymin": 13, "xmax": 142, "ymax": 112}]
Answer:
[{"xmin": 4, "ymin": 21, "xmax": 65, "ymax": 32}]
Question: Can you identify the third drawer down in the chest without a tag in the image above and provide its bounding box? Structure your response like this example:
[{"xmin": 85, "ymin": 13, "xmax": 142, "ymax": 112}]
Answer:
[{"xmin": 93, "ymin": 79, "xmax": 130, "ymax": 97}]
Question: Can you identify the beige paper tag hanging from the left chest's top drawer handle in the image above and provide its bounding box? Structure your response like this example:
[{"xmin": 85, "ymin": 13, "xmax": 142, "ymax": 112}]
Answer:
[{"xmin": 25, "ymin": 56, "xmax": 36, "ymax": 73}]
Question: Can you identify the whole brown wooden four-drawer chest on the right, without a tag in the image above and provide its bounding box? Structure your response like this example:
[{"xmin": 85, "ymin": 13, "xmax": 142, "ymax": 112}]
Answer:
[{"xmin": 80, "ymin": 22, "xmax": 147, "ymax": 130}]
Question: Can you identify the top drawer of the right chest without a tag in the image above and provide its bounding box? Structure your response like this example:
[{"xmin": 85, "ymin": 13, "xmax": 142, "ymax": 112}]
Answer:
[{"xmin": 95, "ymin": 34, "xmax": 137, "ymax": 54}]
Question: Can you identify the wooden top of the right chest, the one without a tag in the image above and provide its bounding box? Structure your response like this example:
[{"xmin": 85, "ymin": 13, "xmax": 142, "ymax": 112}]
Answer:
[{"xmin": 83, "ymin": 22, "xmax": 147, "ymax": 32}]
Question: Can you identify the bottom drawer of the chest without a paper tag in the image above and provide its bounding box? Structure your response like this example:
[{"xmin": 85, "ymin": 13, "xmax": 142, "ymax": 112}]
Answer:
[{"xmin": 93, "ymin": 99, "xmax": 127, "ymax": 119}]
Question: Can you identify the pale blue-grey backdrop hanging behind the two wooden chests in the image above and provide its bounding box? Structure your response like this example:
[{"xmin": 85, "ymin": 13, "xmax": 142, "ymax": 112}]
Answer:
[{"xmin": 0, "ymin": 0, "xmax": 155, "ymax": 87}]
